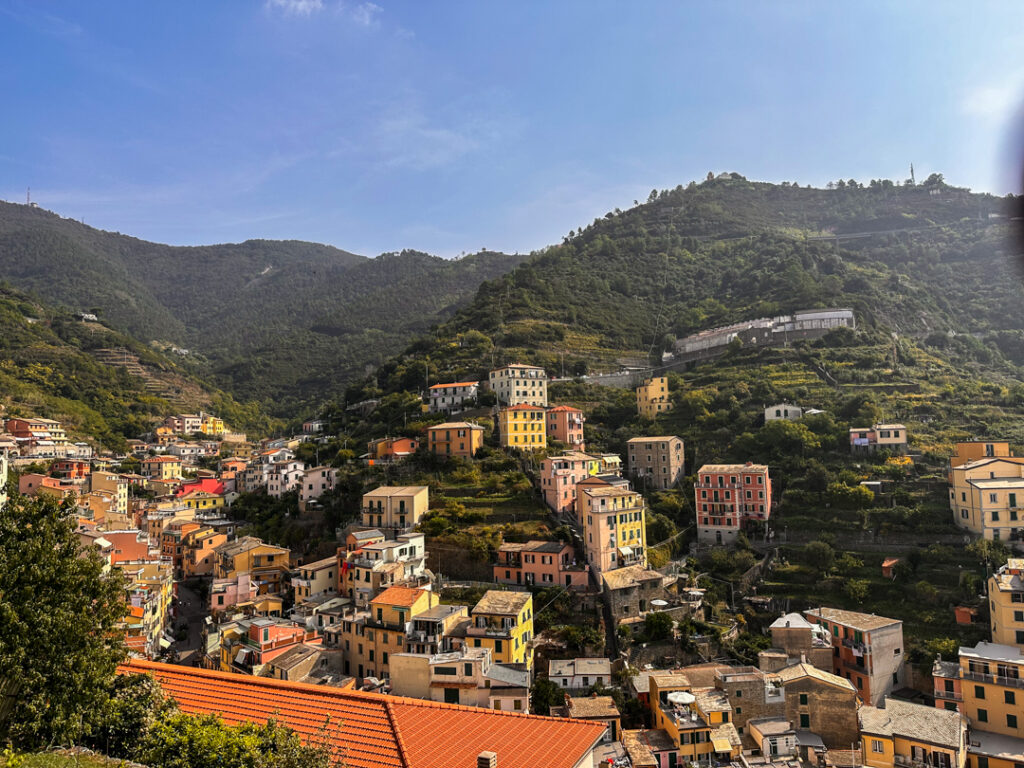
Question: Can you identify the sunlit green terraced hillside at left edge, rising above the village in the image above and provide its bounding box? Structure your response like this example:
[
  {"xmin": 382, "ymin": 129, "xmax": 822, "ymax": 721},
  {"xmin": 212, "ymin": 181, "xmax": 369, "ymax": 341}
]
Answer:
[{"xmin": 0, "ymin": 285, "xmax": 275, "ymax": 447}]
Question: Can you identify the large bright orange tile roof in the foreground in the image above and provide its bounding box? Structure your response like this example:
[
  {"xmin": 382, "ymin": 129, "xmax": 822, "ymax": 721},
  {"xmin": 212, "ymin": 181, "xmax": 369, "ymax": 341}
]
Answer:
[{"xmin": 119, "ymin": 659, "xmax": 604, "ymax": 768}]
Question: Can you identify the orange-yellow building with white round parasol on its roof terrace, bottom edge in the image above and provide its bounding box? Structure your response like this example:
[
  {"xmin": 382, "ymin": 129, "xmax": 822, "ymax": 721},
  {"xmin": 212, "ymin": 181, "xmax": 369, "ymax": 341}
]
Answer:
[{"xmin": 648, "ymin": 672, "xmax": 742, "ymax": 765}]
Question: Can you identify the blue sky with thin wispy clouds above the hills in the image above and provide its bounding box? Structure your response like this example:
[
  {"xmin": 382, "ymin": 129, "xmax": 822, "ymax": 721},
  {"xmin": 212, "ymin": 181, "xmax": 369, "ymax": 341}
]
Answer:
[{"xmin": 0, "ymin": 0, "xmax": 1024, "ymax": 256}]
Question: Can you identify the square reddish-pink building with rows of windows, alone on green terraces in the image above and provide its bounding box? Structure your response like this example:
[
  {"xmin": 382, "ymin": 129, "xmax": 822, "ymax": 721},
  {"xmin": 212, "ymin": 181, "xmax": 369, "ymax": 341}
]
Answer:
[{"xmin": 693, "ymin": 462, "xmax": 771, "ymax": 544}]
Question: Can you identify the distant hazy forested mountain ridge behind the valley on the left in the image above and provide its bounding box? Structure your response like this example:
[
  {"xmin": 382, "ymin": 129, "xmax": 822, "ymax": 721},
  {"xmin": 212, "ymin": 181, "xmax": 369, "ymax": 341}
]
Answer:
[{"xmin": 0, "ymin": 203, "xmax": 525, "ymax": 413}]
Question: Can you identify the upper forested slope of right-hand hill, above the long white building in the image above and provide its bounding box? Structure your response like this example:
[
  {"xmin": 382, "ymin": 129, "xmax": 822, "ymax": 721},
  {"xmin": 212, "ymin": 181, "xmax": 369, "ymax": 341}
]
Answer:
[{"xmin": 352, "ymin": 174, "xmax": 1024, "ymax": 397}]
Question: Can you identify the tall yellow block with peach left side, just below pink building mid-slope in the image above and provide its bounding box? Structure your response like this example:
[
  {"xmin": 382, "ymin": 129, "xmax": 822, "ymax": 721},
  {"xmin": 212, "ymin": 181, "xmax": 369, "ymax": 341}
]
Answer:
[{"xmin": 577, "ymin": 485, "xmax": 647, "ymax": 571}]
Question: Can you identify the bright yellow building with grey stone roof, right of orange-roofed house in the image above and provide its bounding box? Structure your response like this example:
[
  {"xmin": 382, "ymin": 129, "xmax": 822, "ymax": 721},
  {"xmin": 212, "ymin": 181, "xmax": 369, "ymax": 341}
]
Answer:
[{"xmin": 466, "ymin": 590, "xmax": 534, "ymax": 669}]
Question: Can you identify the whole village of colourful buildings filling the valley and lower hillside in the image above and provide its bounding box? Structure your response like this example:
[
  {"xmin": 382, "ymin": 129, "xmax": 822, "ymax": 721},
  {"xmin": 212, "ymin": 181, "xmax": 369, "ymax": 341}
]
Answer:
[{"xmin": 0, "ymin": 348, "xmax": 1024, "ymax": 768}]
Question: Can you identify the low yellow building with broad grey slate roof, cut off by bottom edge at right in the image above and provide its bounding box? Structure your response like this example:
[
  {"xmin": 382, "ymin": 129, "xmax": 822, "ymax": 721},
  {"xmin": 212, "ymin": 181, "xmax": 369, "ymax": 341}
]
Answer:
[{"xmin": 857, "ymin": 697, "xmax": 967, "ymax": 768}]
